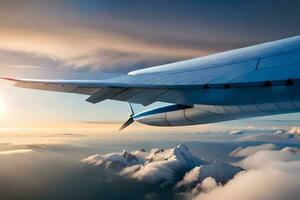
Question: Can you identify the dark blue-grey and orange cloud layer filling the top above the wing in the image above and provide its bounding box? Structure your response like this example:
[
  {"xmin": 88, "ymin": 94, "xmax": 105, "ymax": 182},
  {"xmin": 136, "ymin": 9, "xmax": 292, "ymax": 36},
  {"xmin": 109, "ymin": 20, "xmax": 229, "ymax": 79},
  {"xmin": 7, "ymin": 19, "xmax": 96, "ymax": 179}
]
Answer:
[{"xmin": 0, "ymin": 0, "xmax": 300, "ymax": 71}]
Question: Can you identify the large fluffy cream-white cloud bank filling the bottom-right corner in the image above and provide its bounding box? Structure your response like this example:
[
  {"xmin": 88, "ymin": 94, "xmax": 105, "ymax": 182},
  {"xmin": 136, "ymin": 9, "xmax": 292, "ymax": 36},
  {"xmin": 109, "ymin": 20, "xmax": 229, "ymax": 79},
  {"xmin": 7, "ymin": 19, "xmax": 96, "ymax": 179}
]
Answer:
[{"xmin": 194, "ymin": 145, "xmax": 300, "ymax": 200}]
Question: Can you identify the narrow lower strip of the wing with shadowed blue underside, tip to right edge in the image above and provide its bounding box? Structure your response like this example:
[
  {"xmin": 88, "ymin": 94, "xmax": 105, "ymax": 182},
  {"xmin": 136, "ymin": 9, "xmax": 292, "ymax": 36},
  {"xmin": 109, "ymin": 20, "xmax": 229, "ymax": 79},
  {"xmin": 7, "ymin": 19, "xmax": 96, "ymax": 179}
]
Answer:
[{"xmin": 3, "ymin": 69, "xmax": 300, "ymax": 106}]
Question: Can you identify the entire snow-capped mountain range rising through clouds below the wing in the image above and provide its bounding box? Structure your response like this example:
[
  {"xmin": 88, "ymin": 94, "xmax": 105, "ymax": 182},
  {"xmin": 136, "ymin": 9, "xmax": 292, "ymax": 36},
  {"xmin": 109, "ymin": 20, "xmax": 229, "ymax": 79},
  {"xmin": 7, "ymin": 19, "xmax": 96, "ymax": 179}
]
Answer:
[{"xmin": 82, "ymin": 145, "xmax": 242, "ymax": 190}]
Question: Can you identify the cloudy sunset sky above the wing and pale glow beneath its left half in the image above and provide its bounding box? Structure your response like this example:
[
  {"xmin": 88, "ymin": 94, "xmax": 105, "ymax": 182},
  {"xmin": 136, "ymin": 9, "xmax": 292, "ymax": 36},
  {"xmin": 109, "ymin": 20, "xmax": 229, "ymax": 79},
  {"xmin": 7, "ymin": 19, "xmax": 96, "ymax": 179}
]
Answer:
[{"xmin": 0, "ymin": 0, "xmax": 300, "ymax": 127}]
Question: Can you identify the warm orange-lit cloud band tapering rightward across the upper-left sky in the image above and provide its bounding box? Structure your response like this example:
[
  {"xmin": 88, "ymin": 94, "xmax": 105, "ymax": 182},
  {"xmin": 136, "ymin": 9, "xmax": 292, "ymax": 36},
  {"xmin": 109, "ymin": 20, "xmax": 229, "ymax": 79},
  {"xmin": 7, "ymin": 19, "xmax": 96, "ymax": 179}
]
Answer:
[{"xmin": 0, "ymin": 1, "xmax": 220, "ymax": 69}]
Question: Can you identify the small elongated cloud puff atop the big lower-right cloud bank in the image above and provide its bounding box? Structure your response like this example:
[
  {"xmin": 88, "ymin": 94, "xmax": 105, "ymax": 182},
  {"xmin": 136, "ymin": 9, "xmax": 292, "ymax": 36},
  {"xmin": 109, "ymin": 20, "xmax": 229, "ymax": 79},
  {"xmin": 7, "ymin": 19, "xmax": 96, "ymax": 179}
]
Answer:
[{"xmin": 230, "ymin": 144, "xmax": 277, "ymax": 157}]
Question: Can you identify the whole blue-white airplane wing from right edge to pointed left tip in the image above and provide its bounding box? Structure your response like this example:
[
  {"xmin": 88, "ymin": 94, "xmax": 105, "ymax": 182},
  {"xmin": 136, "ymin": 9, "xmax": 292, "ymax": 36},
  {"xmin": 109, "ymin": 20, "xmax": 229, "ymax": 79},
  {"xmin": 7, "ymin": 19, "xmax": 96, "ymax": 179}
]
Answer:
[{"xmin": 4, "ymin": 34, "xmax": 300, "ymax": 105}]
